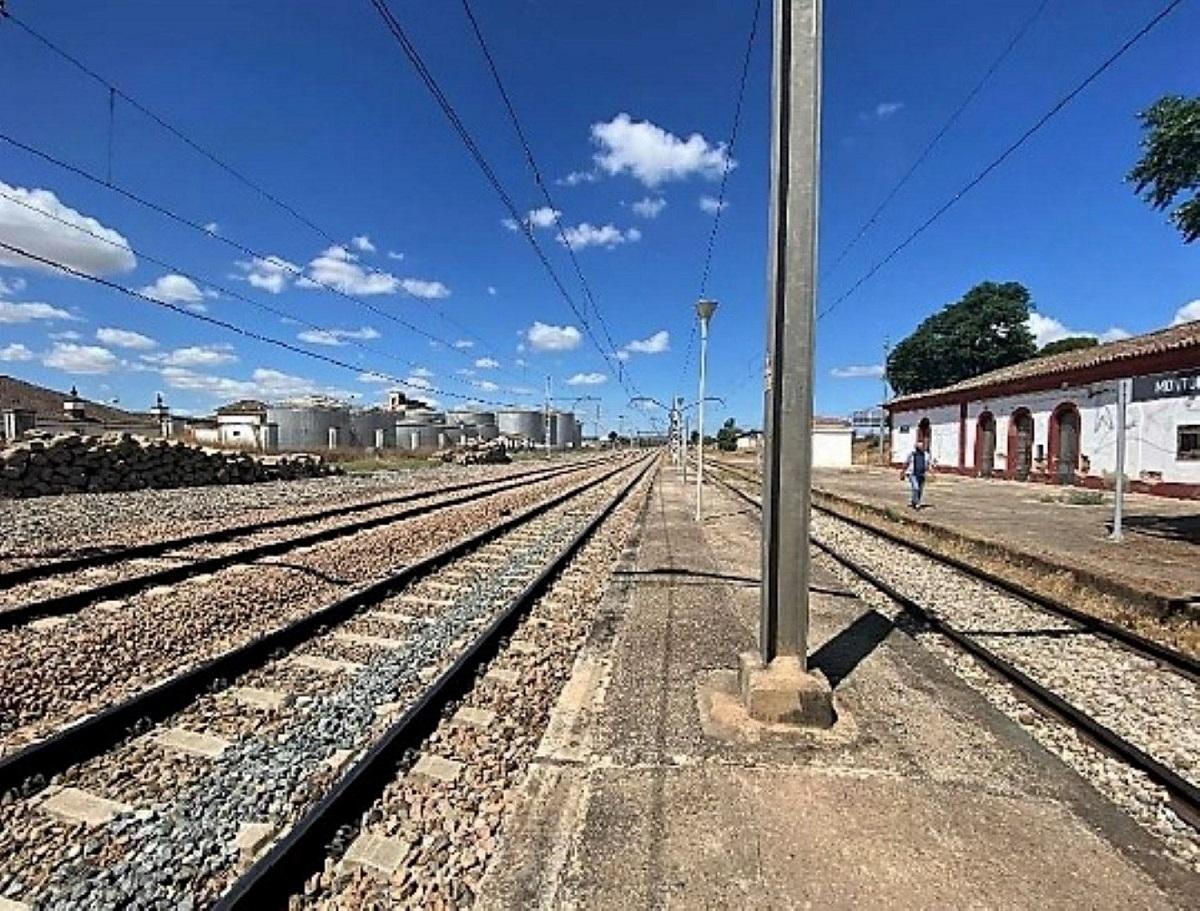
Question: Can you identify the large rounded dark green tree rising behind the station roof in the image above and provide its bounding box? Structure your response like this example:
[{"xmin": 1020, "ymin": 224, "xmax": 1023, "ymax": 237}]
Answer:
[{"xmin": 887, "ymin": 282, "xmax": 1038, "ymax": 395}]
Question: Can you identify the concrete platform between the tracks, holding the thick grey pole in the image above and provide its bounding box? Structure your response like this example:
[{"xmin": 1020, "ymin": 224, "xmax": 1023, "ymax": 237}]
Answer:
[{"xmin": 479, "ymin": 469, "xmax": 1200, "ymax": 911}]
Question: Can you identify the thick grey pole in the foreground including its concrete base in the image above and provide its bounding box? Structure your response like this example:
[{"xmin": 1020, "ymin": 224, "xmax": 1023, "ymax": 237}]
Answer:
[{"xmin": 738, "ymin": 0, "xmax": 833, "ymax": 727}]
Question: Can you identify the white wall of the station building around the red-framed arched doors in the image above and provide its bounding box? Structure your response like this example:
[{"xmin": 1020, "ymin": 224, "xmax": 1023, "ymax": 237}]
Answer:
[{"xmin": 892, "ymin": 382, "xmax": 1200, "ymax": 484}]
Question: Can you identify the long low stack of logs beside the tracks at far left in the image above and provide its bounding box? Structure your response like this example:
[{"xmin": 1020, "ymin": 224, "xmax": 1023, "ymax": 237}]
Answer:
[{"xmin": 0, "ymin": 433, "xmax": 338, "ymax": 497}]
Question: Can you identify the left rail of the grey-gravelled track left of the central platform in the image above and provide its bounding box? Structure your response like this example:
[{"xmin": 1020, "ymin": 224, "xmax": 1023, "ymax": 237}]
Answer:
[{"xmin": 0, "ymin": 461, "xmax": 648, "ymax": 793}]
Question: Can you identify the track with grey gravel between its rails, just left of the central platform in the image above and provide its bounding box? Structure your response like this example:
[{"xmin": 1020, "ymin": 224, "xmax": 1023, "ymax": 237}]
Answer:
[{"xmin": 0, "ymin": 457, "xmax": 654, "ymax": 909}]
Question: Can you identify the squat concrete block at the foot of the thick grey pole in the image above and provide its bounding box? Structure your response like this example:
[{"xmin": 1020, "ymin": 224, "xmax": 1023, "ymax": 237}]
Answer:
[{"xmin": 738, "ymin": 652, "xmax": 834, "ymax": 727}]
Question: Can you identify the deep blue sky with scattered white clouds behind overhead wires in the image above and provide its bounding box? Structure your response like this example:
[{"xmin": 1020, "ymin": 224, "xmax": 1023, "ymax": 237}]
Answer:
[{"xmin": 0, "ymin": 0, "xmax": 1200, "ymax": 432}]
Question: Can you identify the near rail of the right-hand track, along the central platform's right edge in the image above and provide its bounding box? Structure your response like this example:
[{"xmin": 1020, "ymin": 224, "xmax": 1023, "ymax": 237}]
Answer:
[{"xmin": 700, "ymin": 465, "xmax": 1200, "ymax": 829}]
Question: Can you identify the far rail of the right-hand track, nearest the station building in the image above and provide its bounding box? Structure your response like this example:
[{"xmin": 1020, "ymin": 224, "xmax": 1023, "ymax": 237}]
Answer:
[{"xmin": 715, "ymin": 462, "xmax": 1200, "ymax": 682}]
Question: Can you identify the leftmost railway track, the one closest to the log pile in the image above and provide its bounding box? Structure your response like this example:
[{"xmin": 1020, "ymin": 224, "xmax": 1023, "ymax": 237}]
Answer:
[{"xmin": 0, "ymin": 460, "xmax": 602, "ymax": 630}]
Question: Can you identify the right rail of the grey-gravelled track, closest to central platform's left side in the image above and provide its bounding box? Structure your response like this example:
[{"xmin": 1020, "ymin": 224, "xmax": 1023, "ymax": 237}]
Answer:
[{"xmin": 215, "ymin": 456, "xmax": 656, "ymax": 911}]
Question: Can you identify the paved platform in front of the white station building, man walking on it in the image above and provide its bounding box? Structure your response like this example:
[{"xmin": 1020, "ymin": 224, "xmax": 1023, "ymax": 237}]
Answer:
[{"xmin": 812, "ymin": 468, "xmax": 1200, "ymax": 609}]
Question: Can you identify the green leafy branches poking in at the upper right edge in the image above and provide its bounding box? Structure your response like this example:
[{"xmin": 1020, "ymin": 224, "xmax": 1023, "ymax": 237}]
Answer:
[{"xmin": 1126, "ymin": 95, "xmax": 1200, "ymax": 244}]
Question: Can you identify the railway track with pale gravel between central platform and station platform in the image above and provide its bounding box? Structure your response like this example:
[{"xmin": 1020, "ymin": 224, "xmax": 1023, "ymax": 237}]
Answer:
[{"xmin": 710, "ymin": 462, "xmax": 1200, "ymax": 829}]
